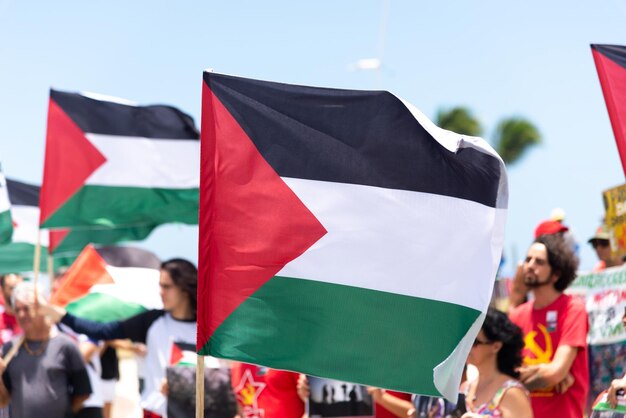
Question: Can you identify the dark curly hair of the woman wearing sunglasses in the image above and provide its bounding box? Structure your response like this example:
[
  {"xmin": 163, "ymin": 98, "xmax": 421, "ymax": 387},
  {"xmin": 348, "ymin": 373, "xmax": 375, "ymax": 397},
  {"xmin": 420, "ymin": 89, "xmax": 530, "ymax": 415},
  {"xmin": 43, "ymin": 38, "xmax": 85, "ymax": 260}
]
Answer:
[{"xmin": 482, "ymin": 308, "xmax": 524, "ymax": 379}]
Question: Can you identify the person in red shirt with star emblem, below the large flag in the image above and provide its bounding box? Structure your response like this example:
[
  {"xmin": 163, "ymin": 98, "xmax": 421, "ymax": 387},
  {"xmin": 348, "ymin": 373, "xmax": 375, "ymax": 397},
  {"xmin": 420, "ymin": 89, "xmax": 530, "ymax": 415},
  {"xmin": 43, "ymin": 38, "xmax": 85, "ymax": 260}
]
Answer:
[{"xmin": 230, "ymin": 362, "xmax": 304, "ymax": 418}]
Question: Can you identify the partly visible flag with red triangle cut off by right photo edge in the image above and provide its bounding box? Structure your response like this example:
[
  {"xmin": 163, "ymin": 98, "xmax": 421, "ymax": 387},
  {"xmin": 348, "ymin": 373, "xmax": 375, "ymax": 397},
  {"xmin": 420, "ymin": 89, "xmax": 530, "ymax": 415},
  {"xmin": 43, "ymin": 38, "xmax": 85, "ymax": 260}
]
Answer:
[{"xmin": 591, "ymin": 44, "xmax": 626, "ymax": 174}]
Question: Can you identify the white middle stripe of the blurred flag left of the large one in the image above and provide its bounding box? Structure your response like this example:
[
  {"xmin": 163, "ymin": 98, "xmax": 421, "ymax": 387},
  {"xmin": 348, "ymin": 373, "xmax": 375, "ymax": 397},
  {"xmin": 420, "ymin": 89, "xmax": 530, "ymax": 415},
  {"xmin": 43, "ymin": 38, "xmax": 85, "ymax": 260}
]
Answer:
[{"xmin": 85, "ymin": 133, "xmax": 200, "ymax": 189}]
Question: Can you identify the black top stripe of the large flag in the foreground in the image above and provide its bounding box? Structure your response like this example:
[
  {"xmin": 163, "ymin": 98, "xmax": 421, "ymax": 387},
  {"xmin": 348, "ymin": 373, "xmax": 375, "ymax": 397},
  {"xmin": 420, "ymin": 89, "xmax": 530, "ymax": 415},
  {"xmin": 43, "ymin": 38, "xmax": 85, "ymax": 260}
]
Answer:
[{"xmin": 204, "ymin": 72, "xmax": 501, "ymax": 207}]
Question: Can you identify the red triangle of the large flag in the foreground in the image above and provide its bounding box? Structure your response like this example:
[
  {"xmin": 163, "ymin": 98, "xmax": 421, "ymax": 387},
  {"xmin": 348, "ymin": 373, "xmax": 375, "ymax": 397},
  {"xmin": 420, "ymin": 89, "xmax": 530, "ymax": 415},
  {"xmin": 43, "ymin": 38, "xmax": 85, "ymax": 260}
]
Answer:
[{"xmin": 197, "ymin": 83, "xmax": 327, "ymax": 350}]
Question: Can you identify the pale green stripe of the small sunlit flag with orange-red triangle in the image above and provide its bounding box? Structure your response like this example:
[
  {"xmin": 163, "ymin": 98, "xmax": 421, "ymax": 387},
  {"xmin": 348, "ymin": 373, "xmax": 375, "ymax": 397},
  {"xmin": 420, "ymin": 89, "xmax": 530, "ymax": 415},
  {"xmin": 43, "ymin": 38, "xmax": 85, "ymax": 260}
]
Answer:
[{"xmin": 65, "ymin": 293, "xmax": 146, "ymax": 322}]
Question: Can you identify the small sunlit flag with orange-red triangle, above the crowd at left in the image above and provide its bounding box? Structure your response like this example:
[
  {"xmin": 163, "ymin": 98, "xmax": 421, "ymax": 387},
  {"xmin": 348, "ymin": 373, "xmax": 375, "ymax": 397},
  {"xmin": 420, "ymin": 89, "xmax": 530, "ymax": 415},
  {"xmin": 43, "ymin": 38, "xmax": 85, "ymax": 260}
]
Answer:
[{"xmin": 51, "ymin": 245, "xmax": 162, "ymax": 322}]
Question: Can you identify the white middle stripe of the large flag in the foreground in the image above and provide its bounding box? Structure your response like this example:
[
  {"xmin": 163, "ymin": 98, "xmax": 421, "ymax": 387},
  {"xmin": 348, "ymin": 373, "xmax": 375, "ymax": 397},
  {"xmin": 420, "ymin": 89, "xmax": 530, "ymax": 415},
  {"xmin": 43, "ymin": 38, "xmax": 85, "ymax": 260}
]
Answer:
[{"xmin": 277, "ymin": 178, "xmax": 506, "ymax": 311}]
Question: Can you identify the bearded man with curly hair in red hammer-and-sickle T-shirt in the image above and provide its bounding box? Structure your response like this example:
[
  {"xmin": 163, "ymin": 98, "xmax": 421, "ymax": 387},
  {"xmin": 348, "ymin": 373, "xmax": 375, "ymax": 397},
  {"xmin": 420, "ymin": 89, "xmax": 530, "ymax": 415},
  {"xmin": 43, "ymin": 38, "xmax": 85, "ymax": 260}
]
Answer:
[{"xmin": 510, "ymin": 235, "xmax": 589, "ymax": 418}]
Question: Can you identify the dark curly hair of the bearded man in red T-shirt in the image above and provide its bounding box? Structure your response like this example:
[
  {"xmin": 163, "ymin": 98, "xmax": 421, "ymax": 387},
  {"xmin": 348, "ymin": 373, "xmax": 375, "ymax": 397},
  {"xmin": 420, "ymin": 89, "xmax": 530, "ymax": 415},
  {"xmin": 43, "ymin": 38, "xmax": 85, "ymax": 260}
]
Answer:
[{"xmin": 535, "ymin": 235, "xmax": 579, "ymax": 292}]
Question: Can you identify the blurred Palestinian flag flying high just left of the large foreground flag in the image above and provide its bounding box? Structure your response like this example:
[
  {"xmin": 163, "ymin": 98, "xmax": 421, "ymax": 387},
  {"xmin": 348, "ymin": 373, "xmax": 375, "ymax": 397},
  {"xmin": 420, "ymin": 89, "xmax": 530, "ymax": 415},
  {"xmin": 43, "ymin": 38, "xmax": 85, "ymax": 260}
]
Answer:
[{"xmin": 40, "ymin": 90, "xmax": 199, "ymax": 230}]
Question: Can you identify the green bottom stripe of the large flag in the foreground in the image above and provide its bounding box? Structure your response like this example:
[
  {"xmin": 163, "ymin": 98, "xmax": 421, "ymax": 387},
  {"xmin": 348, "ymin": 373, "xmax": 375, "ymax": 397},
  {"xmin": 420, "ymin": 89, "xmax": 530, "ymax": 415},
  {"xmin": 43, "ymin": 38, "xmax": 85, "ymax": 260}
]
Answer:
[{"xmin": 200, "ymin": 276, "xmax": 480, "ymax": 395}]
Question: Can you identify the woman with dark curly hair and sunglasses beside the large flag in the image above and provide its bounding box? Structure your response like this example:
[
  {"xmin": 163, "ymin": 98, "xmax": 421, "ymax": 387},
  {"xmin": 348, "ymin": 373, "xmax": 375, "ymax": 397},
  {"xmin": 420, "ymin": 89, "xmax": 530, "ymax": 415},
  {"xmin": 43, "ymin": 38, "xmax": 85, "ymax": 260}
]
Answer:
[{"xmin": 462, "ymin": 308, "xmax": 533, "ymax": 418}]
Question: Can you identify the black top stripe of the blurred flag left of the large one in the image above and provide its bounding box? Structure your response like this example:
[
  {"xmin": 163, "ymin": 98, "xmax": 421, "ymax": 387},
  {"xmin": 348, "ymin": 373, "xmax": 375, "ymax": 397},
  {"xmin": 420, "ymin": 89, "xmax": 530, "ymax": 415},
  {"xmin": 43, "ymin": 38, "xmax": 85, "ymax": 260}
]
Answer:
[{"xmin": 50, "ymin": 90, "xmax": 199, "ymax": 139}]
